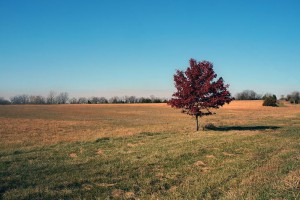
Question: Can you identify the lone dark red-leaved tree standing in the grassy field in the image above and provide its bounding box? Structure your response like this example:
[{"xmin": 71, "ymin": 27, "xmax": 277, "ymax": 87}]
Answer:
[{"xmin": 168, "ymin": 59, "xmax": 233, "ymax": 131}]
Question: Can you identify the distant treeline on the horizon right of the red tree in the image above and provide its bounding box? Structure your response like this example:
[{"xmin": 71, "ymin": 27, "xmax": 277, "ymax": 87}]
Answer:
[{"xmin": 235, "ymin": 90, "xmax": 300, "ymax": 104}]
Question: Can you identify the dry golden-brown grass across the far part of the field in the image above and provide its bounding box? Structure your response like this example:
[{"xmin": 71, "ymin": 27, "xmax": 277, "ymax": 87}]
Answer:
[{"xmin": 0, "ymin": 101, "xmax": 300, "ymax": 146}]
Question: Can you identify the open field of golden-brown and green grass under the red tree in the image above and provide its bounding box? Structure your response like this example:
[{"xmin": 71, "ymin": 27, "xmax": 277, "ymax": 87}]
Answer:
[{"xmin": 0, "ymin": 101, "xmax": 300, "ymax": 199}]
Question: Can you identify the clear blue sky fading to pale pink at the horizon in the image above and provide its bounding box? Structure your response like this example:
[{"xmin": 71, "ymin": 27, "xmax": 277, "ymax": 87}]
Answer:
[{"xmin": 0, "ymin": 0, "xmax": 300, "ymax": 98}]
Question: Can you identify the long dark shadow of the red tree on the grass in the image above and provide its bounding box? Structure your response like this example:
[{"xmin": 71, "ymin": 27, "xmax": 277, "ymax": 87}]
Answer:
[{"xmin": 205, "ymin": 126, "xmax": 280, "ymax": 131}]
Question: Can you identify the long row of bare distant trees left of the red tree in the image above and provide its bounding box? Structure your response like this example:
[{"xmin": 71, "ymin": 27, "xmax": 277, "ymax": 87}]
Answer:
[{"xmin": 0, "ymin": 91, "xmax": 167, "ymax": 105}]
